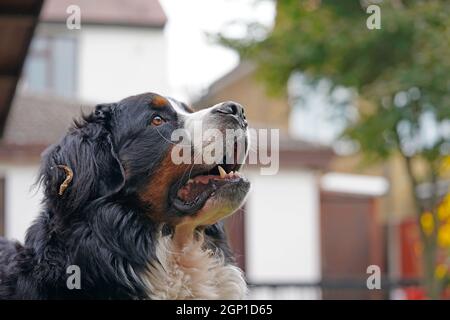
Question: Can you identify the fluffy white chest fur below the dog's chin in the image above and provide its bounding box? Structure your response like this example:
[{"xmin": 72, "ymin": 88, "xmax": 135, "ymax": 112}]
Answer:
[{"xmin": 142, "ymin": 232, "xmax": 247, "ymax": 299}]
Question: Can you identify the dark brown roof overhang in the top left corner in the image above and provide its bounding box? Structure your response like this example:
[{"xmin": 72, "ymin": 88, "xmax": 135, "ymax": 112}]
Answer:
[{"xmin": 0, "ymin": 0, "xmax": 43, "ymax": 135}]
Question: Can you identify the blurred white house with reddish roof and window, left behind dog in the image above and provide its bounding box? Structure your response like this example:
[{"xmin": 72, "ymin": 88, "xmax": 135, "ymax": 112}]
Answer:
[{"xmin": 0, "ymin": 0, "xmax": 169, "ymax": 240}]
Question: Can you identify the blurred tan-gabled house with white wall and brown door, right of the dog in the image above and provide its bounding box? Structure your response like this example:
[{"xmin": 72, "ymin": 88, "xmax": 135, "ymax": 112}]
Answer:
[{"xmin": 195, "ymin": 62, "xmax": 389, "ymax": 298}]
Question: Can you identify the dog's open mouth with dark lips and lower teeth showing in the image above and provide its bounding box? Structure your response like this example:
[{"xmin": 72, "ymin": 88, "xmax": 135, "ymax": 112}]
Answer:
[{"xmin": 170, "ymin": 164, "xmax": 247, "ymax": 214}]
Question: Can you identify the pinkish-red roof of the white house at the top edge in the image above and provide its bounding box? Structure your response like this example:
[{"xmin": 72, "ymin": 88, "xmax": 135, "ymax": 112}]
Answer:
[{"xmin": 41, "ymin": 0, "xmax": 167, "ymax": 28}]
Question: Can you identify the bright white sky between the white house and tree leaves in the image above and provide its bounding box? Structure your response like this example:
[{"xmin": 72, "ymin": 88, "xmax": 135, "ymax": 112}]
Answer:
[{"xmin": 160, "ymin": 0, "xmax": 275, "ymax": 101}]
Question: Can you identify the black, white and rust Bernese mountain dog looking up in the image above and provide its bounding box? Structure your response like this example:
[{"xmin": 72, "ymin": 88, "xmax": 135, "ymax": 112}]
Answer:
[{"xmin": 0, "ymin": 93, "xmax": 250, "ymax": 299}]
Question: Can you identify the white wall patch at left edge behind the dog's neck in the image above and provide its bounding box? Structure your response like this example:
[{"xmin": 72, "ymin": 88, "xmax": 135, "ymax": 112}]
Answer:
[{"xmin": 0, "ymin": 164, "xmax": 42, "ymax": 241}]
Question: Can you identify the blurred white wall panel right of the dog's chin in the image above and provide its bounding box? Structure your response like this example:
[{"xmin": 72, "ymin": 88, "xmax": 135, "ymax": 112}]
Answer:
[{"xmin": 246, "ymin": 170, "xmax": 321, "ymax": 282}]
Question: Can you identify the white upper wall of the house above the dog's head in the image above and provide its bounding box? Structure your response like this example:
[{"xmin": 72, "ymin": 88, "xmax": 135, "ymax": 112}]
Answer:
[{"xmin": 78, "ymin": 26, "xmax": 170, "ymax": 102}]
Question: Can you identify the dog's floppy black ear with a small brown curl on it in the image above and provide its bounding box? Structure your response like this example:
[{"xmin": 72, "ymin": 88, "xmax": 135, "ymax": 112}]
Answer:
[{"xmin": 40, "ymin": 104, "xmax": 125, "ymax": 211}]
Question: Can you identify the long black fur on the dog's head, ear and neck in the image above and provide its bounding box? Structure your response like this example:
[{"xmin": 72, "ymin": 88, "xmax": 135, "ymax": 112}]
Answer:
[{"xmin": 0, "ymin": 94, "xmax": 231, "ymax": 299}]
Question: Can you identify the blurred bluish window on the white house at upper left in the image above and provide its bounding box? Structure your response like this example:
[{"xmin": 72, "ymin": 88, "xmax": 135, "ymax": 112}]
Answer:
[{"xmin": 23, "ymin": 36, "xmax": 76, "ymax": 97}]
